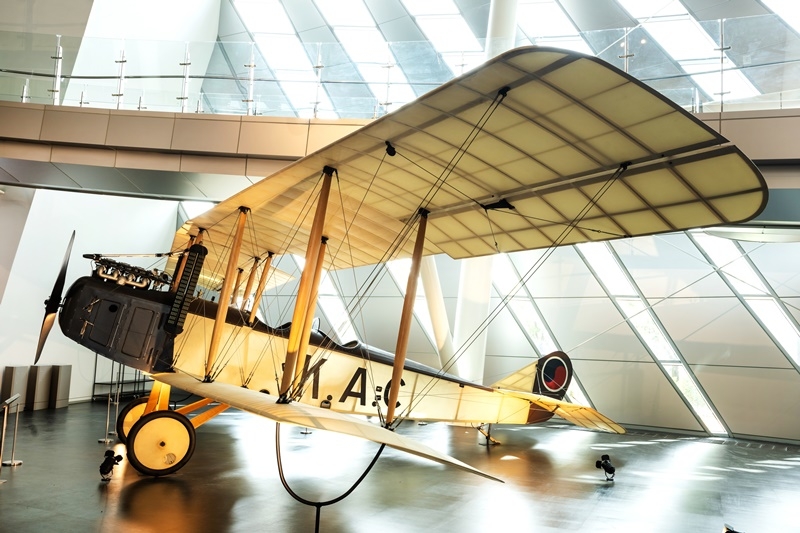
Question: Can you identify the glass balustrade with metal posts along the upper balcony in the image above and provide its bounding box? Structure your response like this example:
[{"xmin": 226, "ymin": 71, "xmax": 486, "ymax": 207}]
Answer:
[{"xmin": 0, "ymin": 17, "xmax": 800, "ymax": 118}]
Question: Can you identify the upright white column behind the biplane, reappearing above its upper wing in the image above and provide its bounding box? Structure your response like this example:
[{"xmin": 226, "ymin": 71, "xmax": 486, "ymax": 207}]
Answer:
[{"xmin": 454, "ymin": 0, "xmax": 517, "ymax": 383}]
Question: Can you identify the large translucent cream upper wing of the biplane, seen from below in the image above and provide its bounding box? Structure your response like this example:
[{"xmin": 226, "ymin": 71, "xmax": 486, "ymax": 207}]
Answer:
[{"xmin": 176, "ymin": 47, "xmax": 767, "ymax": 271}]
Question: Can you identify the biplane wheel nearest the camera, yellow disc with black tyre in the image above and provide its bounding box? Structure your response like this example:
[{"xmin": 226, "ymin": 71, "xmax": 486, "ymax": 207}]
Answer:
[{"xmin": 127, "ymin": 411, "xmax": 196, "ymax": 476}]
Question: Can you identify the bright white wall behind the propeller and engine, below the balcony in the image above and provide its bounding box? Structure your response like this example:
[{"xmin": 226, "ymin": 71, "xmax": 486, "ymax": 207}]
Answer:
[{"xmin": 0, "ymin": 190, "xmax": 178, "ymax": 401}]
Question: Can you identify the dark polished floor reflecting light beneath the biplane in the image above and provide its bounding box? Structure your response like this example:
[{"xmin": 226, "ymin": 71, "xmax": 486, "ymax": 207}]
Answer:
[{"xmin": 0, "ymin": 396, "xmax": 800, "ymax": 533}]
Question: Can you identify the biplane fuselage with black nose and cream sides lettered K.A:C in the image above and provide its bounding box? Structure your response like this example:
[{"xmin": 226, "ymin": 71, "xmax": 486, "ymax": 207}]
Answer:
[{"xmin": 59, "ymin": 275, "xmax": 568, "ymax": 424}]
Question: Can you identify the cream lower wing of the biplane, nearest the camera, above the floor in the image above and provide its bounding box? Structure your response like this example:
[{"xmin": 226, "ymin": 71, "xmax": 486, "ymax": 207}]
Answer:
[{"xmin": 152, "ymin": 373, "xmax": 502, "ymax": 482}]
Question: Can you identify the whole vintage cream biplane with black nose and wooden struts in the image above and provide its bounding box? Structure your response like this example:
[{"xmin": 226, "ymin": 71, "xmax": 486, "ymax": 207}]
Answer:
[{"xmin": 36, "ymin": 47, "xmax": 767, "ymax": 486}]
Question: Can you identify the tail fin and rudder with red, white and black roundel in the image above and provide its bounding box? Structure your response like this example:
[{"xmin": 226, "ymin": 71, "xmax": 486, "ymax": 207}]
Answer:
[{"xmin": 492, "ymin": 352, "xmax": 572, "ymax": 400}]
